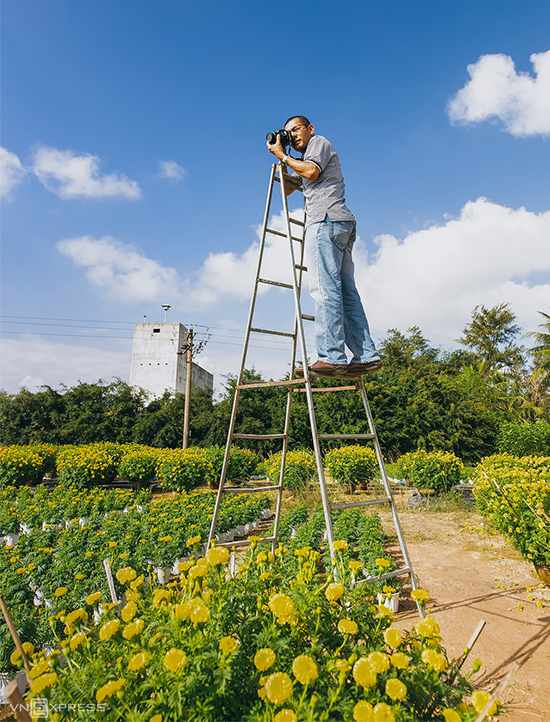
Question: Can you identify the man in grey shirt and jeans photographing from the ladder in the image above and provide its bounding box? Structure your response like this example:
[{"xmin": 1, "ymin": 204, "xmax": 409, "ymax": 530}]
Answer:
[{"xmin": 267, "ymin": 115, "xmax": 382, "ymax": 377}]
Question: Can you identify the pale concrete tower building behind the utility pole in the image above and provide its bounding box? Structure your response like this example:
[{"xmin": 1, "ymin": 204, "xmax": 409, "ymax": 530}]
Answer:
[{"xmin": 130, "ymin": 322, "xmax": 214, "ymax": 398}]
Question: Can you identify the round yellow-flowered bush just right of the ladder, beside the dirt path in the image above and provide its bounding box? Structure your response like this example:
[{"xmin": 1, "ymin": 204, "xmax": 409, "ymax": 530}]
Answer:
[{"xmin": 397, "ymin": 450, "xmax": 464, "ymax": 491}]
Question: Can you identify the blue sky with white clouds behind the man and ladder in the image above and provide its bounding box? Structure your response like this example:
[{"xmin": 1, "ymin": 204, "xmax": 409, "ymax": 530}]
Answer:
[{"xmin": 0, "ymin": 0, "xmax": 550, "ymax": 392}]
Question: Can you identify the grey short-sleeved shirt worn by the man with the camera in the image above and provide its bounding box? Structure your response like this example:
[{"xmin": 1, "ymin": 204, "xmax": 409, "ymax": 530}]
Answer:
[{"xmin": 302, "ymin": 135, "xmax": 355, "ymax": 226}]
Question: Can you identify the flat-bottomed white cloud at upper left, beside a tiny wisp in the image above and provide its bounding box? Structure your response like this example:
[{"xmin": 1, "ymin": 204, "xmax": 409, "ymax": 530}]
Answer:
[{"xmin": 33, "ymin": 148, "xmax": 141, "ymax": 199}]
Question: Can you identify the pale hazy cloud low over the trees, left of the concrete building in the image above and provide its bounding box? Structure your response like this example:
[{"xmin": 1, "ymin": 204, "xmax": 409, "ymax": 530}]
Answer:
[{"xmin": 0, "ymin": 334, "xmax": 132, "ymax": 393}]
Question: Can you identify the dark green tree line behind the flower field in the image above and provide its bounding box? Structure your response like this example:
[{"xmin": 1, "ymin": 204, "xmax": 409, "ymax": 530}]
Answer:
[{"xmin": 0, "ymin": 304, "xmax": 550, "ymax": 463}]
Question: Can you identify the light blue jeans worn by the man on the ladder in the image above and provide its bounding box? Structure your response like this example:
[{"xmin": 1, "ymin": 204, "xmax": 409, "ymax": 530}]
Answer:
[{"xmin": 306, "ymin": 215, "xmax": 380, "ymax": 365}]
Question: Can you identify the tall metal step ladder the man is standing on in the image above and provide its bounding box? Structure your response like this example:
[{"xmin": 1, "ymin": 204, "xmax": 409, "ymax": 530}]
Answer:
[{"xmin": 208, "ymin": 162, "xmax": 417, "ymax": 589}]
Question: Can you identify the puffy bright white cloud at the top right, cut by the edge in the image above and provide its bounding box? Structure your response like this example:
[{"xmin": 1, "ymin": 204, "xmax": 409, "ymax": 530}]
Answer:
[{"xmin": 447, "ymin": 50, "xmax": 550, "ymax": 137}]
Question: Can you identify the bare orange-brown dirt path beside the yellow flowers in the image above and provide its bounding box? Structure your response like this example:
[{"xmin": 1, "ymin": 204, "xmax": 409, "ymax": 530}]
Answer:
[{"xmin": 382, "ymin": 511, "xmax": 550, "ymax": 722}]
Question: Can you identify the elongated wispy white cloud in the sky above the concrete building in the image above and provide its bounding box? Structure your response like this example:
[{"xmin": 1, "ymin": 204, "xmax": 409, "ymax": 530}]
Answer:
[{"xmin": 57, "ymin": 236, "xmax": 180, "ymax": 303}]
